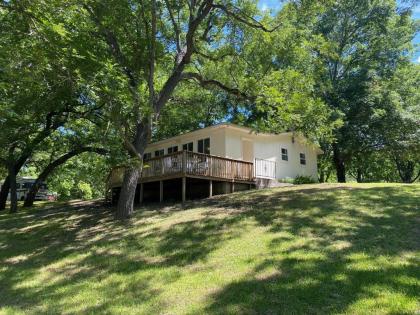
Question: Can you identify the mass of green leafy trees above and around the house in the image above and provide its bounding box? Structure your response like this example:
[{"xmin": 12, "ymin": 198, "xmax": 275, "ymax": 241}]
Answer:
[{"xmin": 0, "ymin": 0, "xmax": 420, "ymax": 218}]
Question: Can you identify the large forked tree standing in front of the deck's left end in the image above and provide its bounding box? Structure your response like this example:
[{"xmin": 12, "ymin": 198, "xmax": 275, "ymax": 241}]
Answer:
[{"xmin": 72, "ymin": 0, "xmax": 278, "ymax": 218}]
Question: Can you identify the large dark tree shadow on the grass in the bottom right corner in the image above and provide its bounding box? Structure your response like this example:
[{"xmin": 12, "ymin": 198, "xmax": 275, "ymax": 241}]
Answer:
[{"xmin": 206, "ymin": 255, "xmax": 418, "ymax": 314}]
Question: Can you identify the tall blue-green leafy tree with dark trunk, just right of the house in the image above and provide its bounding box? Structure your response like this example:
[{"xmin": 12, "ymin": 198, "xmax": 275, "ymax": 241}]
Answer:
[{"xmin": 313, "ymin": 0, "xmax": 415, "ymax": 181}]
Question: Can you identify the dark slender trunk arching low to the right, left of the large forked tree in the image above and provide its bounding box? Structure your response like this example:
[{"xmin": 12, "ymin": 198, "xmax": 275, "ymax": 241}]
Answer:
[{"xmin": 23, "ymin": 147, "xmax": 108, "ymax": 207}]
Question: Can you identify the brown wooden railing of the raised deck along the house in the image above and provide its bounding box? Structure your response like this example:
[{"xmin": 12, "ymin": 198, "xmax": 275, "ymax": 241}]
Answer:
[{"xmin": 108, "ymin": 151, "xmax": 255, "ymax": 188}]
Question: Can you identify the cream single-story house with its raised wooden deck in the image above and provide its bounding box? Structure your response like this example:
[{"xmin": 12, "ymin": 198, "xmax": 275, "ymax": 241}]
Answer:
[{"xmin": 108, "ymin": 123, "xmax": 323, "ymax": 202}]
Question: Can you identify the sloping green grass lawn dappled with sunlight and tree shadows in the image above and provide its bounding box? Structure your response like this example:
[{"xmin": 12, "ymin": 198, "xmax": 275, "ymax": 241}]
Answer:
[{"xmin": 0, "ymin": 184, "xmax": 420, "ymax": 314}]
